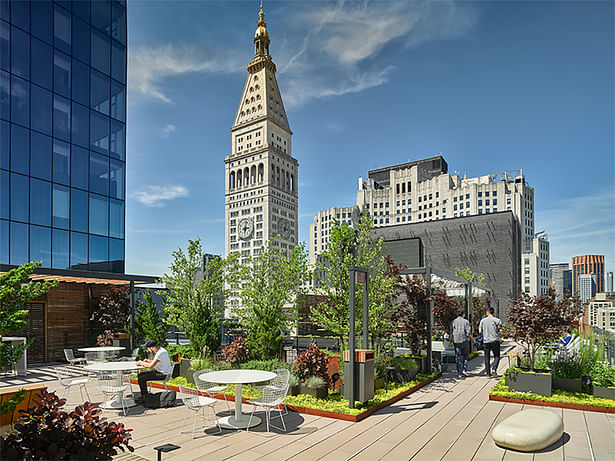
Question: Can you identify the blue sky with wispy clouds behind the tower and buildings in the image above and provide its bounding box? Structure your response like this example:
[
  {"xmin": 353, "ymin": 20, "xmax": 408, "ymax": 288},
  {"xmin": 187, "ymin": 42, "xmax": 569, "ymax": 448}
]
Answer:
[{"xmin": 126, "ymin": 0, "xmax": 615, "ymax": 275}]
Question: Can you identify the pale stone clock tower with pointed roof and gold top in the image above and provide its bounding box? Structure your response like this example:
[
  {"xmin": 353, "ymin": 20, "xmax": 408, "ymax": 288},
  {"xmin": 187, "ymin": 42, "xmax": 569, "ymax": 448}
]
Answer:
[{"xmin": 224, "ymin": 3, "xmax": 299, "ymax": 263}]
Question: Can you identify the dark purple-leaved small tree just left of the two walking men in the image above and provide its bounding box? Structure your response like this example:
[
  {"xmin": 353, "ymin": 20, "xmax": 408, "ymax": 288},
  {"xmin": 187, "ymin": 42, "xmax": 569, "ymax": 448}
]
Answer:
[{"xmin": 394, "ymin": 278, "xmax": 430, "ymax": 354}]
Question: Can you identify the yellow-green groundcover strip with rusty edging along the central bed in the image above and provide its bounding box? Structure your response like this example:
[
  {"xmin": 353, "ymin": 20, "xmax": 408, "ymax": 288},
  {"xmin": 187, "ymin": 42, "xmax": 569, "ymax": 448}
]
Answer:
[{"xmin": 131, "ymin": 373, "xmax": 442, "ymax": 422}]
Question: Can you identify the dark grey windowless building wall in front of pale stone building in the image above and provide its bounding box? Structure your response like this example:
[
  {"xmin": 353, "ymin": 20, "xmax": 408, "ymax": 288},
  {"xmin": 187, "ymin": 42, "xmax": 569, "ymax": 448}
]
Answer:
[{"xmin": 375, "ymin": 211, "xmax": 521, "ymax": 321}]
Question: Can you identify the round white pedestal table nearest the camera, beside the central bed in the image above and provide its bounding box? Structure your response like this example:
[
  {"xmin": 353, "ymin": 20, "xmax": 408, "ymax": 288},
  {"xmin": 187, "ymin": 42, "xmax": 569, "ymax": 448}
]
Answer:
[{"xmin": 199, "ymin": 370, "xmax": 277, "ymax": 429}]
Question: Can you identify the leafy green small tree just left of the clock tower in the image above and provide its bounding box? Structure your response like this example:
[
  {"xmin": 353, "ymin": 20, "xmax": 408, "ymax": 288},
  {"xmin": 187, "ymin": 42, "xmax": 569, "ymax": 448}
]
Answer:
[{"xmin": 160, "ymin": 238, "xmax": 226, "ymax": 353}]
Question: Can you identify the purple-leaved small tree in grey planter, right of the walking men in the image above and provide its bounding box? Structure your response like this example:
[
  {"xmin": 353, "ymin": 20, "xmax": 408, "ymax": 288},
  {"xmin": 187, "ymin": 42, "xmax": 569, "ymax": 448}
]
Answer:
[{"xmin": 505, "ymin": 289, "xmax": 579, "ymax": 396}]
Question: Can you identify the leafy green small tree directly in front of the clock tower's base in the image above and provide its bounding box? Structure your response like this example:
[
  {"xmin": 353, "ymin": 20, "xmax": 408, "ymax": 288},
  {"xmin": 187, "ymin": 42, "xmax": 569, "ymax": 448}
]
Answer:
[{"xmin": 234, "ymin": 238, "xmax": 310, "ymax": 360}]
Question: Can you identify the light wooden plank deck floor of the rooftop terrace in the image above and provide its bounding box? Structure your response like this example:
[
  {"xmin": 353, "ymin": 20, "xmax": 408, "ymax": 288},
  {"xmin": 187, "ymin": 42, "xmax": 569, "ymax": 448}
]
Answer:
[{"xmin": 0, "ymin": 346, "xmax": 615, "ymax": 461}]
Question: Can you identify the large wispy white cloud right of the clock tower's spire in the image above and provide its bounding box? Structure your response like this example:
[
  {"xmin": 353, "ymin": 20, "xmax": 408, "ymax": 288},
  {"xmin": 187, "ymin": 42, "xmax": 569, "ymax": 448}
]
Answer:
[{"xmin": 279, "ymin": 1, "xmax": 477, "ymax": 107}]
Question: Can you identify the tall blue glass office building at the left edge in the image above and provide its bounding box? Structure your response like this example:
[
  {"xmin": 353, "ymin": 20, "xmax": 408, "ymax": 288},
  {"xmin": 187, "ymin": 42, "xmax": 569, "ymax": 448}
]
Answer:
[{"xmin": 0, "ymin": 0, "xmax": 126, "ymax": 273}]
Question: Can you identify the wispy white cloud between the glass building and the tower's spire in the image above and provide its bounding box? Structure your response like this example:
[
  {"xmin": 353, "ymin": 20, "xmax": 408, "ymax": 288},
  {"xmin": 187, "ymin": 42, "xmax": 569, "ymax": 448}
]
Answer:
[{"xmin": 128, "ymin": 44, "xmax": 245, "ymax": 103}]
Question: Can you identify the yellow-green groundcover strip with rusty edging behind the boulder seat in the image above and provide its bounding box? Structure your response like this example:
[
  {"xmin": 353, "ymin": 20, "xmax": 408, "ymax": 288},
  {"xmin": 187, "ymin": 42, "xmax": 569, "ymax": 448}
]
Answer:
[{"xmin": 489, "ymin": 378, "xmax": 615, "ymax": 413}]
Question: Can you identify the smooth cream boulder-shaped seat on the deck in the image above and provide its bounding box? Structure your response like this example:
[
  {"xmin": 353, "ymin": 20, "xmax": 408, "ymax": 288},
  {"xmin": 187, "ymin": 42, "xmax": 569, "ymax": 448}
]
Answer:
[{"xmin": 491, "ymin": 409, "xmax": 564, "ymax": 451}]
